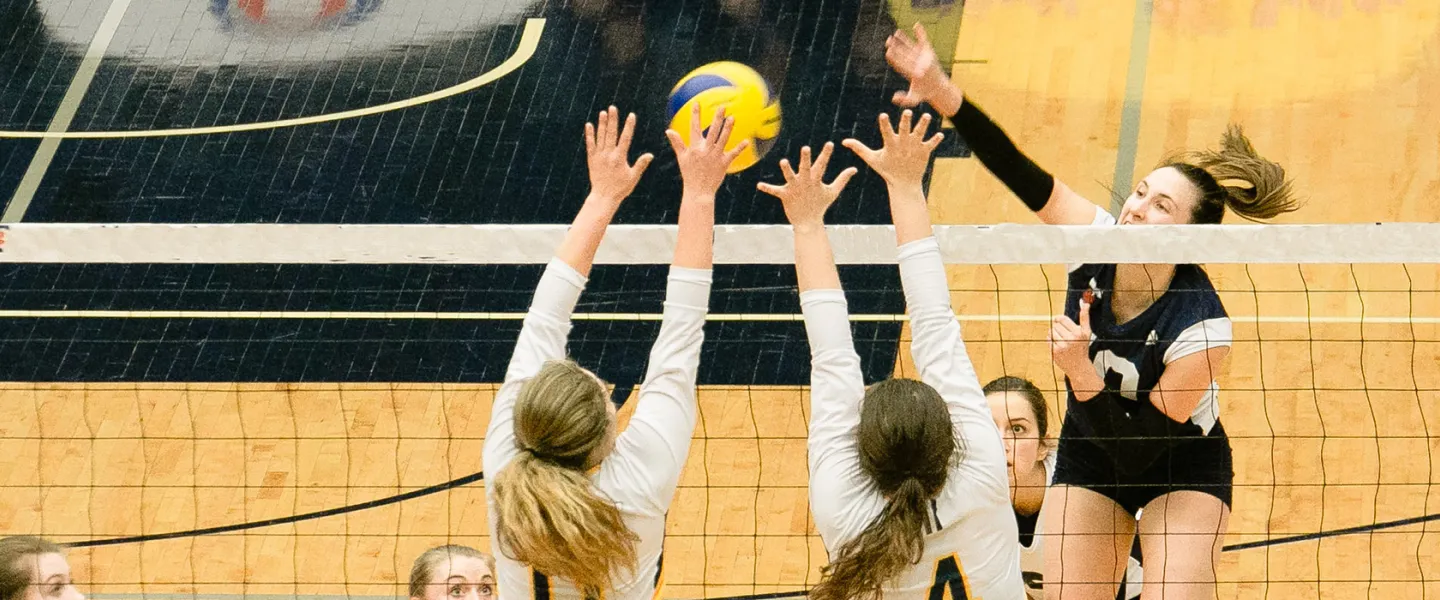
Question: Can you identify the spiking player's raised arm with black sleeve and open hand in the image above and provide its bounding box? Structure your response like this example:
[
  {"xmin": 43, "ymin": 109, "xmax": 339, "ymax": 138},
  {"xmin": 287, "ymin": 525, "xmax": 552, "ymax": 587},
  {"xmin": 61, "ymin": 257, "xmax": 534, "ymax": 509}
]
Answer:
[{"xmin": 886, "ymin": 23, "xmax": 1100, "ymax": 224}]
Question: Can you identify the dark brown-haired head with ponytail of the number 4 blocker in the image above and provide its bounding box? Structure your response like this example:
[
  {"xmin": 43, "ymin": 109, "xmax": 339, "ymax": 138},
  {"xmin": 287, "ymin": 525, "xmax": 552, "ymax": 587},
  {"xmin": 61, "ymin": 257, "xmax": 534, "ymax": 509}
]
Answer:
[{"xmin": 809, "ymin": 378, "xmax": 959, "ymax": 600}]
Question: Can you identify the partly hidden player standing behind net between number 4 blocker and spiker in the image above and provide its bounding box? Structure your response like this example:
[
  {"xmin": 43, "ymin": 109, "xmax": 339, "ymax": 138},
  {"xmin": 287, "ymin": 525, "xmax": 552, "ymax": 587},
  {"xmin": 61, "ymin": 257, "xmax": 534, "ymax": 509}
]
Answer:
[{"xmin": 984, "ymin": 376, "xmax": 1143, "ymax": 600}]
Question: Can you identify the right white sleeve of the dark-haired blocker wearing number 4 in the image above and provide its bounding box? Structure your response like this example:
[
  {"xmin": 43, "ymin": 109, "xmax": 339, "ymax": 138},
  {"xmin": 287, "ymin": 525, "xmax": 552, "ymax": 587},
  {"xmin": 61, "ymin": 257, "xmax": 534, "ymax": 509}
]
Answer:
[{"xmin": 900, "ymin": 237, "xmax": 1009, "ymax": 494}]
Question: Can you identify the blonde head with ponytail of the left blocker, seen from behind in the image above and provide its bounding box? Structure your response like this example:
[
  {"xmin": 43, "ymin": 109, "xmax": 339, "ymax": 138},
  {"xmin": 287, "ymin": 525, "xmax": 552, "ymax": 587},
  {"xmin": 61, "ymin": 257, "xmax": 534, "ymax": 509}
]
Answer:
[{"xmin": 492, "ymin": 361, "xmax": 638, "ymax": 594}]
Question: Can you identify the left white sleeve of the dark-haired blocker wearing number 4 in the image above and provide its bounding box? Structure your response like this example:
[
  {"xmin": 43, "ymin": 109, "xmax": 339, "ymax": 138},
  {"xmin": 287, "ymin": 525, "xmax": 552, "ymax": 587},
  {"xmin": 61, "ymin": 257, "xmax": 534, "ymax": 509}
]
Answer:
[{"xmin": 801, "ymin": 289, "xmax": 875, "ymax": 551}]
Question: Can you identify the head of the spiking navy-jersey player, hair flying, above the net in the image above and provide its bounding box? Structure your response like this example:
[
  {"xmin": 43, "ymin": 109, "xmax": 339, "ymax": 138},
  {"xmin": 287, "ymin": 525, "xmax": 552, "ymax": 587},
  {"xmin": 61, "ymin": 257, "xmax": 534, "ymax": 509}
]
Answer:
[{"xmin": 1119, "ymin": 125, "xmax": 1299, "ymax": 224}]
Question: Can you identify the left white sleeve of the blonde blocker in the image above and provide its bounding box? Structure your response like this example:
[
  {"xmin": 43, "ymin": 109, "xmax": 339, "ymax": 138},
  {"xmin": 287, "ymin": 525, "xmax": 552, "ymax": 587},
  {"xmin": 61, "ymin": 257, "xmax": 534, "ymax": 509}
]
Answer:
[{"xmin": 481, "ymin": 259, "xmax": 586, "ymax": 480}]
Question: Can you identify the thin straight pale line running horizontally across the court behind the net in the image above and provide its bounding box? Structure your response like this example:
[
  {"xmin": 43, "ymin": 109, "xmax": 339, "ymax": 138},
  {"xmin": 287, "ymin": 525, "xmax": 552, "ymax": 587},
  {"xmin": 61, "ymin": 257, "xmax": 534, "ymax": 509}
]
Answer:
[{"xmin": 0, "ymin": 309, "xmax": 1440, "ymax": 325}]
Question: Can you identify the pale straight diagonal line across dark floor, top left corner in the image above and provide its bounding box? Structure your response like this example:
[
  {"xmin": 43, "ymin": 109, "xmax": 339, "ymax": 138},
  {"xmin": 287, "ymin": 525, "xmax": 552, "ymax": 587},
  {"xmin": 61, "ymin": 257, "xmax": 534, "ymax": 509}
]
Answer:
[{"xmin": 0, "ymin": 0, "xmax": 130, "ymax": 223}]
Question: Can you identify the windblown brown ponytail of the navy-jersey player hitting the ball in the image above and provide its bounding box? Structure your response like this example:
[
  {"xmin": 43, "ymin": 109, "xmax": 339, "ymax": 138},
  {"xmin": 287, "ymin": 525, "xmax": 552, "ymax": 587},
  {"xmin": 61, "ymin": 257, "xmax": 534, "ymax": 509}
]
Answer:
[{"xmin": 1165, "ymin": 125, "xmax": 1300, "ymax": 224}]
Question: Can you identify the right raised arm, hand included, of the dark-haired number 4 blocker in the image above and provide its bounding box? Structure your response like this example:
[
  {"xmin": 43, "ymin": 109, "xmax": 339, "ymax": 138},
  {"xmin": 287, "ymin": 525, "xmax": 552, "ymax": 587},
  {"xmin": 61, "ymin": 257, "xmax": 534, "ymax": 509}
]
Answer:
[{"xmin": 844, "ymin": 111, "xmax": 1007, "ymax": 483}]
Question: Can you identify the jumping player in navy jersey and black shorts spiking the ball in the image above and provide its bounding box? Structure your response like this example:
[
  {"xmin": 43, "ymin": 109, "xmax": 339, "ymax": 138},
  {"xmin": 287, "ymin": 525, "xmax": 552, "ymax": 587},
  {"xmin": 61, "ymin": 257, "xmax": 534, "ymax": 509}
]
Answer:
[{"xmin": 886, "ymin": 24, "xmax": 1296, "ymax": 600}]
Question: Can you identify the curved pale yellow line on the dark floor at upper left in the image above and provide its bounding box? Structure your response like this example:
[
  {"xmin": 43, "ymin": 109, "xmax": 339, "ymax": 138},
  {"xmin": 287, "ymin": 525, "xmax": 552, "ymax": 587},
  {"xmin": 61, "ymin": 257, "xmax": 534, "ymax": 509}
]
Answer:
[{"xmin": 0, "ymin": 19, "xmax": 546, "ymax": 140}]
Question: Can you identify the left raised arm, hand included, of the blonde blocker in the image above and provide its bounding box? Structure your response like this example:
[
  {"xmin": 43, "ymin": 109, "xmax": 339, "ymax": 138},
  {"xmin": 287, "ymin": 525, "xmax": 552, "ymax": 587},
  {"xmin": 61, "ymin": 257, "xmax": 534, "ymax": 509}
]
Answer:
[{"xmin": 482, "ymin": 106, "xmax": 654, "ymax": 473}]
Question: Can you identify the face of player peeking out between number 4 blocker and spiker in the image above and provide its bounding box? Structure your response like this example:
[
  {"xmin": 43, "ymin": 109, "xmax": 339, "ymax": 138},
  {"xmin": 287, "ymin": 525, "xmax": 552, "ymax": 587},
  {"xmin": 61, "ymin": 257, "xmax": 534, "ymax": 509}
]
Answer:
[{"xmin": 985, "ymin": 376, "xmax": 1051, "ymax": 486}]
